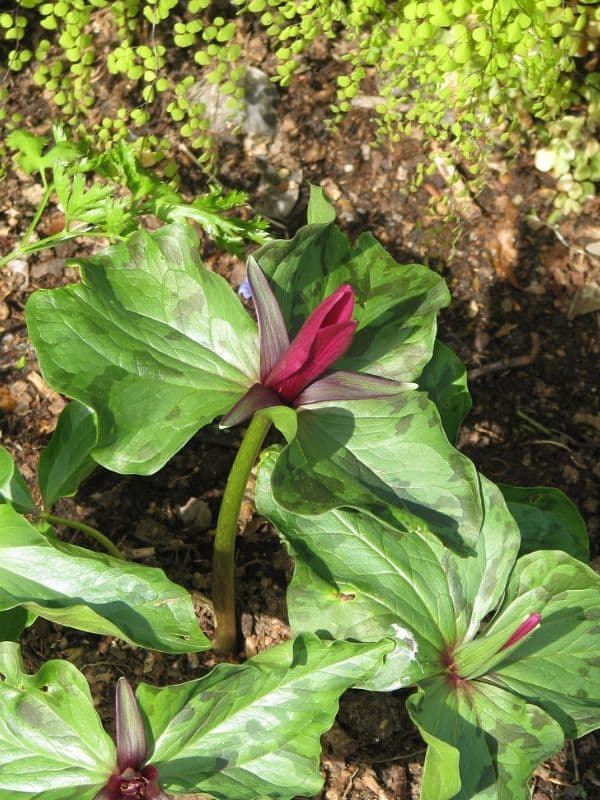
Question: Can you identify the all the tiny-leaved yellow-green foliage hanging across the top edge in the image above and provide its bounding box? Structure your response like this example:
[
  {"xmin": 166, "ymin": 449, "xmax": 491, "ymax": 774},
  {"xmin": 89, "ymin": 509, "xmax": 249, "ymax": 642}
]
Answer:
[{"xmin": 0, "ymin": 0, "xmax": 600, "ymax": 212}]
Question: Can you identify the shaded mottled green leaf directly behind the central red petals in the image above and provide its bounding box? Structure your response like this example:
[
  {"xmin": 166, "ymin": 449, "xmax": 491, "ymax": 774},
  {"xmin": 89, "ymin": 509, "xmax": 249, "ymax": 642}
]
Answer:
[{"xmin": 254, "ymin": 219, "xmax": 450, "ymax": 382}]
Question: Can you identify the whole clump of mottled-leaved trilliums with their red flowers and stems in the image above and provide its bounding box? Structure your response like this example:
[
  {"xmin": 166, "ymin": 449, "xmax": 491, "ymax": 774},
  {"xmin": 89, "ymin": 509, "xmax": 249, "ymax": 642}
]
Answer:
[{"xmin": 0, "ymin": 188, "xmax": 600, "ymax": 800}]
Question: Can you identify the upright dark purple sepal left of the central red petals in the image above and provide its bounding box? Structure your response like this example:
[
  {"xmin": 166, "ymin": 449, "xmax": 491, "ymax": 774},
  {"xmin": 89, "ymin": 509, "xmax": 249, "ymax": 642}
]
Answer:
[{"xmin": 248, "ymin": 256, "xmax": 290, "ymax": 381}]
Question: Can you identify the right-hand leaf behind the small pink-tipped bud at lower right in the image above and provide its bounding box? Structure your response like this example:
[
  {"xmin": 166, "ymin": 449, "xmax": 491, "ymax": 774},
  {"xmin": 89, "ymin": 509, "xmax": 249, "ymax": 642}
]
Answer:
[{"xmin": 486, "ymin": 550, "xmax": 600, "ymax": 738}]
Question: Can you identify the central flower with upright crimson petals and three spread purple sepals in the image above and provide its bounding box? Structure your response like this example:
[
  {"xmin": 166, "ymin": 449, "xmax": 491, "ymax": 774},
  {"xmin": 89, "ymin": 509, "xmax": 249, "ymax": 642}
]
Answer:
[{"xmin": 221, "ymin": 258, "xmax": 414, "ymax": 428}]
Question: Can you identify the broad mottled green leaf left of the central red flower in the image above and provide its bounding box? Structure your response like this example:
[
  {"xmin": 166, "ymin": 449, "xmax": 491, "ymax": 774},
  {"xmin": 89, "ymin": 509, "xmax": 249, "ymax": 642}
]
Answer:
[{"xmin": 27, "ymin": 224, "xmax": 258, "ymax": 474}]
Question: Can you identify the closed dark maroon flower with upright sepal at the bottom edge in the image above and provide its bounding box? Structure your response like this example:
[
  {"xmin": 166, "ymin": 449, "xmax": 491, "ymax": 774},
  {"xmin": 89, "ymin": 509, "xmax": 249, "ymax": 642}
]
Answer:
[{"xmin": 94, "ymin": 678, "xmax": 169, "ymax": 800}]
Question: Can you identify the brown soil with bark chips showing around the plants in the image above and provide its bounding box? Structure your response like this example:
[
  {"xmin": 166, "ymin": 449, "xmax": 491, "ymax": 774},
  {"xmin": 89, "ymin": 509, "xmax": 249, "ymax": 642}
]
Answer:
[{"xmin": 0, "ymin": 21, "xmax": 600, "ymax": 800}]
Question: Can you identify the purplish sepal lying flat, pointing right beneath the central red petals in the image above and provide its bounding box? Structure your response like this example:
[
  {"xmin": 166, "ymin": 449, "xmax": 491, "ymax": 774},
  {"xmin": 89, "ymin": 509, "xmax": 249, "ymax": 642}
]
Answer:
[{"xmin": 293, "ymin": 371, "xmax": 417, "ymax": 408}]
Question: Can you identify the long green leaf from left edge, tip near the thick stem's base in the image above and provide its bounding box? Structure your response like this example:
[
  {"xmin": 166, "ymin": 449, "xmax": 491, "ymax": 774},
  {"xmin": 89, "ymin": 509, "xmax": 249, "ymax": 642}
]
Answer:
[{"xmin": 0, "ymin": 506, "xmax": 210, "ymax": 653}]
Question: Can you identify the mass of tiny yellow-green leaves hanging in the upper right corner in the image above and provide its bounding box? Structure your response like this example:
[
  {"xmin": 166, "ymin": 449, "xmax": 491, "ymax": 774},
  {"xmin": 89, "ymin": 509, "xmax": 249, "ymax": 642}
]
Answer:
[{"xmin": 238, "ymin": 0, "xmax": 600, "ymax": 216}]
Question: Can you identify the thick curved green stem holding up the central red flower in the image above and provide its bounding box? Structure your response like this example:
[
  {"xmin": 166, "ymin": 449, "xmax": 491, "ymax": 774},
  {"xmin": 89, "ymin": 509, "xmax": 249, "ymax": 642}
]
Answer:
[{"xmin": 212, "ymin": 414, "xmax": 271, "ymax": 653}]
